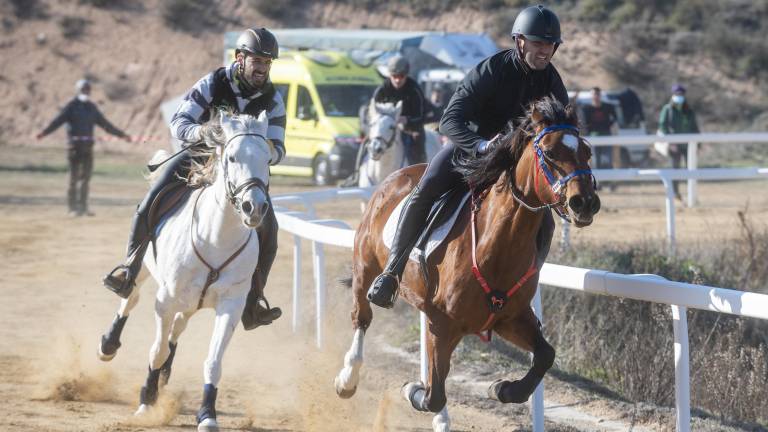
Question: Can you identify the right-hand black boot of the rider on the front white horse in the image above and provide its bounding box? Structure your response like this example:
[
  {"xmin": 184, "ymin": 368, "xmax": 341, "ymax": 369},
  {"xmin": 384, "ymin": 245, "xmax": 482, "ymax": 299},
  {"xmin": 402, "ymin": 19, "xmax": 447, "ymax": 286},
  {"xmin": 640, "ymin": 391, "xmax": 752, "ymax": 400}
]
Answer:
[{"xmin": 241, "ymin": 202, "xmax": 283, "ymax": 330}]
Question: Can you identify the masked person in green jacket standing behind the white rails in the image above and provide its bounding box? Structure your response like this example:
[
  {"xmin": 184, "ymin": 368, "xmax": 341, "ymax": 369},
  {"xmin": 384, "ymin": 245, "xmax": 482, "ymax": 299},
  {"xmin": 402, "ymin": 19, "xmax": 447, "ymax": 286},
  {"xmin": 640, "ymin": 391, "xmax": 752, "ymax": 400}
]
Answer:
[{"xmin": 659, "ymin": 84, "xmax": 699, "ymax": 199}]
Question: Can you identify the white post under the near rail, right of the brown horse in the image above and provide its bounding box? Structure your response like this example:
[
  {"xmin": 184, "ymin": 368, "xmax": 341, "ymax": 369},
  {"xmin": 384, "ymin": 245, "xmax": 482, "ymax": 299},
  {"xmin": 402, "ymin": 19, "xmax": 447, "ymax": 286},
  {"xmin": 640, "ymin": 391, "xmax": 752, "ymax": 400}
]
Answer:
[{"xmin": 671, "ymin": 305, "xmax": 691, "ymax": 432}]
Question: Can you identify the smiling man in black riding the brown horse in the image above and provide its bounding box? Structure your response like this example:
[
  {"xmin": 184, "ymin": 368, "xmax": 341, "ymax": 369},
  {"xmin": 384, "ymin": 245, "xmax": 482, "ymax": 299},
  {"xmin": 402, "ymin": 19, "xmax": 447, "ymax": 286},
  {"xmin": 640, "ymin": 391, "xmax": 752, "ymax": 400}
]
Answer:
[{"xmin": 368, "ymin": 5, "xmax": 568, "ymax": 308}]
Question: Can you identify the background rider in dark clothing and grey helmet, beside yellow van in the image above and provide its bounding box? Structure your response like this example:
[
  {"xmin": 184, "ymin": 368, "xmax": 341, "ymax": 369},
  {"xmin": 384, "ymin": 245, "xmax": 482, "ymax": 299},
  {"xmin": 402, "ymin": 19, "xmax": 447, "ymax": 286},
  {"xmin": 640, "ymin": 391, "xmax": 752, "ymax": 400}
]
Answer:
[{"xmin": 373, "ymin": 55, "xmax": 427, "ymax": 165}]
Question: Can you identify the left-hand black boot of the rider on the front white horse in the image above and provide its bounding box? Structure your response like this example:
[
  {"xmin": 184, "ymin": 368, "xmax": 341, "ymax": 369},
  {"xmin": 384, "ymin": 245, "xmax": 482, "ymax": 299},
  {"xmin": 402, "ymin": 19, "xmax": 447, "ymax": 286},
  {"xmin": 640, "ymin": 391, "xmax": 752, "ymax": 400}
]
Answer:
[{"xmin": 104, "ymin": 210, "xmax": 149, "ymax": 298}]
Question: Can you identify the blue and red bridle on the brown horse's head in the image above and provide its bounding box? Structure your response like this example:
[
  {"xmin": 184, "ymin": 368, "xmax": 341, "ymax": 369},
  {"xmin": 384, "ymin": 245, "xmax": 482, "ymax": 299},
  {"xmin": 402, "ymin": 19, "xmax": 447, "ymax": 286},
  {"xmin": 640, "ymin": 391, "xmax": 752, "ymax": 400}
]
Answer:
[{"xmin": 512, "ymin": 124, "xmax": 597, "ymax": 223}]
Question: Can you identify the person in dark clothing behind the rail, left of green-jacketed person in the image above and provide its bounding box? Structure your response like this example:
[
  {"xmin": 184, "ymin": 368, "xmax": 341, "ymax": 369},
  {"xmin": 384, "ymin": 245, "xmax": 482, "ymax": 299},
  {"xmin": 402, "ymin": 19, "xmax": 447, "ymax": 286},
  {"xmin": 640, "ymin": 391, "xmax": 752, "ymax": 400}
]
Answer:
[{"xmin": 579, "ymin": 87, "xmax": 621, "ymax": 168}]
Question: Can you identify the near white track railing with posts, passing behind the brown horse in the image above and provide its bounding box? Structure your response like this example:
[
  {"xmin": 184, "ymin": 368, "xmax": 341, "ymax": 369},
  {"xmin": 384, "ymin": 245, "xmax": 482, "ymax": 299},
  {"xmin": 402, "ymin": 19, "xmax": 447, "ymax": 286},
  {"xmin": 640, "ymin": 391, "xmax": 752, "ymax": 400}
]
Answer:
[{"xmin": 273, "ymin": 187, "xmax": 768, "ymax": 432}]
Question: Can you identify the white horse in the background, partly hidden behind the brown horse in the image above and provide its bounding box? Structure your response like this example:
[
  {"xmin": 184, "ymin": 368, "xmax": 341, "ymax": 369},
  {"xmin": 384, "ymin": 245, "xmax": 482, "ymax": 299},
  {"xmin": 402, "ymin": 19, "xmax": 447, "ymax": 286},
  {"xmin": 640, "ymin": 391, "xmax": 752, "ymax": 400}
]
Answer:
[{"xmin": 358, "ymin": 102, "xmax": 441, "ymax": 187}]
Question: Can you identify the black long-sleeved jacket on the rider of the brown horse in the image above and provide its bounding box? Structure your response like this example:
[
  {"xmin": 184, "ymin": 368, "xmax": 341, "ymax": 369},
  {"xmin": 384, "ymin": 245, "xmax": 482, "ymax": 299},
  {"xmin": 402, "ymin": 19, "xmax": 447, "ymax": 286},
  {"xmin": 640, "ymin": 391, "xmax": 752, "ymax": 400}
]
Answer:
[{"xmin": 440, "ymin": 50, "xmax": 568, "ymax": 156}]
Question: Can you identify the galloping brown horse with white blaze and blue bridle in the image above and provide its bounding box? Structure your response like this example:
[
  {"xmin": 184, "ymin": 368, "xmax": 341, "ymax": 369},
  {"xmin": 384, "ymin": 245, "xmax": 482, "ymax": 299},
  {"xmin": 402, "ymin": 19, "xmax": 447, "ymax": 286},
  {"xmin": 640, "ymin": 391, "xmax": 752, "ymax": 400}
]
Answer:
[{"xmin": 335, "ymin": 98, "xmax": 600, "ymax": 430}]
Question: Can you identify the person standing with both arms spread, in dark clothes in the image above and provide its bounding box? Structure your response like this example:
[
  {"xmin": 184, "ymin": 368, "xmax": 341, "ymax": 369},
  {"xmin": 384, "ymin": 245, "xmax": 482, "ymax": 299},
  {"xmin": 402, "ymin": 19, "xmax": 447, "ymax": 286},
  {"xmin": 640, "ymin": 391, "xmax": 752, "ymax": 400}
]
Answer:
[{"xmin": 37, "ymin": 79, "xmax": 131, "ymax": 216}]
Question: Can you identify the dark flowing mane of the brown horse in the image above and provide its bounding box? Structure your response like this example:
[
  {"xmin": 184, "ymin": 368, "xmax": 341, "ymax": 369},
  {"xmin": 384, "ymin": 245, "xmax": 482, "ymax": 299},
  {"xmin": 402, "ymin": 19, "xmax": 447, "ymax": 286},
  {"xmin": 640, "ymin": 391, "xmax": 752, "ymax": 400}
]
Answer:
[{"xmin": 455, "ymin": 96, "xmax": 577, "ymax": 191}]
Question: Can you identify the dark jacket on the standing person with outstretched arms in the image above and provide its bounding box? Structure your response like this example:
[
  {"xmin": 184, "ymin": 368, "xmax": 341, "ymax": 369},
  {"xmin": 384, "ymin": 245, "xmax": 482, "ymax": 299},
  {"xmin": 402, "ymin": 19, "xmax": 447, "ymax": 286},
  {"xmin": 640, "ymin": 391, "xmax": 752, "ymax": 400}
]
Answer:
[{"xmin": 42, "ymin": 98, "xmax": 126, "ymax": 144}]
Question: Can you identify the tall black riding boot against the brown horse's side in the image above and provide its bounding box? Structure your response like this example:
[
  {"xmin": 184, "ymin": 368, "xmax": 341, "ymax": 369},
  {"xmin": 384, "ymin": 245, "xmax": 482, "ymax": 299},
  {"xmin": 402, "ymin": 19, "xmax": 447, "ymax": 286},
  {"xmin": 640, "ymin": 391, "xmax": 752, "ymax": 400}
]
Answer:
[{"xmin": 368, "ymin": 185, "xmax": 433, "ymax": 309}]
